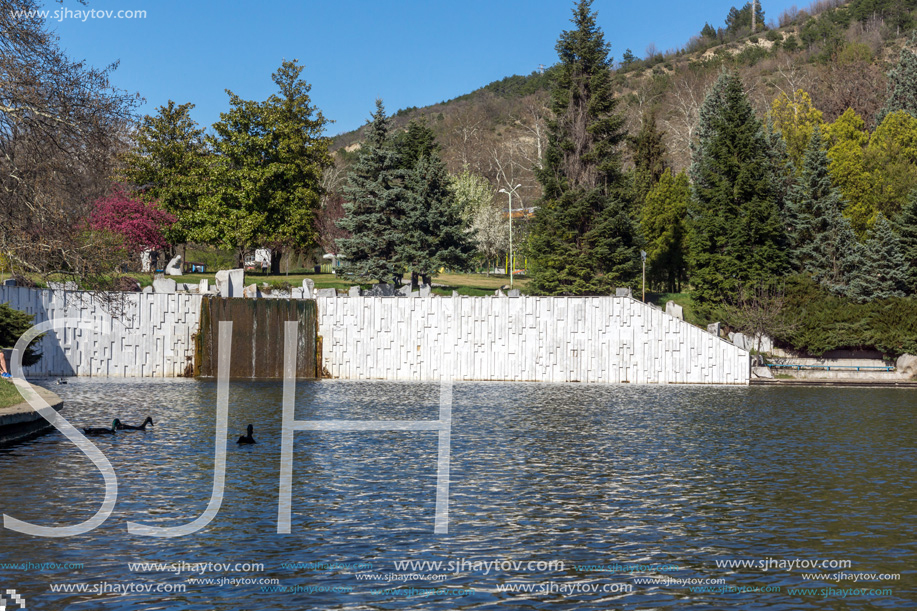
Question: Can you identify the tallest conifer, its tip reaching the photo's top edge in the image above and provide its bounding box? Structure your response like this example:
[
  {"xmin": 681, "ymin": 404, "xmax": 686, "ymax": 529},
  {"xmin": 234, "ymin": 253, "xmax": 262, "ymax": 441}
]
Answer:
[{"xmin": 528, "ymin": 0, "xmax": 639, "ymax": 295}]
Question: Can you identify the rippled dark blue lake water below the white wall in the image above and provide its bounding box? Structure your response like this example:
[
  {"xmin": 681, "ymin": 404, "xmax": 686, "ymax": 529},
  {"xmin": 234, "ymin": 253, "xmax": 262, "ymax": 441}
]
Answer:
[{"xmin": 0, "ymin": 379, "xmax": 917, "ymax": 610}]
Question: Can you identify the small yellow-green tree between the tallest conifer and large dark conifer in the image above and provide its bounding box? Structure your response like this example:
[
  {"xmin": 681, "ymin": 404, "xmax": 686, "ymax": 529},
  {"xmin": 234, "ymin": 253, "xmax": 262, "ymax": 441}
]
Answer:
[{"xmin": 640, "ymin": 169, "xmax": 691, "ymax": 293}]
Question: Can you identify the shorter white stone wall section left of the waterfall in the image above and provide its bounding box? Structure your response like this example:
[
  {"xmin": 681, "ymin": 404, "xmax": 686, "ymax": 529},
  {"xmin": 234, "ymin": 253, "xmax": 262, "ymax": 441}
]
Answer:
[{"xmin": 0, "ymin": 286, "xmax": 201, "ymax": 377}]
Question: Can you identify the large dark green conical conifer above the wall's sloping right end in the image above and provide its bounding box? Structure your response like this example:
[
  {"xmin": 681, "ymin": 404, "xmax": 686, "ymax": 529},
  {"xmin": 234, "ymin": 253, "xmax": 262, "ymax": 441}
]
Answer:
[{"xmin": 689, "ymin": 72, "xmax": 787, "ymax": 315}]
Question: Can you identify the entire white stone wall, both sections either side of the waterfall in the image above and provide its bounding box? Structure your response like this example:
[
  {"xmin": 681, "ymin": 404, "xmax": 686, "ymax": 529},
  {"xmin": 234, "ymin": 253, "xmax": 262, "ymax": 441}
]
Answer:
[{"xmin": 0, "ymin": 286, "xmax": 750, "ymax": 384}]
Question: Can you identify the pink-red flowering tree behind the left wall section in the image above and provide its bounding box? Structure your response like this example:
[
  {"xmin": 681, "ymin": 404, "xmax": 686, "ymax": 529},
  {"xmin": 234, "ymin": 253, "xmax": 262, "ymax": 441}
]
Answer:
[{"xmin": 89, "ymin": 185, "xmax": 175, "ymax": 253}]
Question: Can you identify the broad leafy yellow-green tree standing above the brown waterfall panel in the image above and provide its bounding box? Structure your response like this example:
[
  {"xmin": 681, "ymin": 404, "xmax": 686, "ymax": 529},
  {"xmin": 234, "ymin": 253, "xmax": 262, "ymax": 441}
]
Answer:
[{"xmin": 208, "ymin": 61, "xmax": 333, "ymax": 274}]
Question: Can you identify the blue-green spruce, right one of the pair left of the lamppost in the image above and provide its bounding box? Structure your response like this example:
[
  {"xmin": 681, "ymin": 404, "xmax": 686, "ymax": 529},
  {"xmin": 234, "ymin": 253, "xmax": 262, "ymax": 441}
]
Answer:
[{"xmin": 397, "ymin": 149, "xmax": 474, "ymax": 286}]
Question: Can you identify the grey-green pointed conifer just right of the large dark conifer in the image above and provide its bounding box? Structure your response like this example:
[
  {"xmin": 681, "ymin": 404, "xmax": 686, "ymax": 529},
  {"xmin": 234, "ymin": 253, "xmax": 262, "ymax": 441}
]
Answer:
[{"xmin": 785, "ymin": 127, "xmax": 863, "ymax": 295}]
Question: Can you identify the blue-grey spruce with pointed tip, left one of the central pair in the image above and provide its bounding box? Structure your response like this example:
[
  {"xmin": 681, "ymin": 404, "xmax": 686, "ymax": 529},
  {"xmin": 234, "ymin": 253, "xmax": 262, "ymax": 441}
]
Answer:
[{"xmin": 338, "ymin": 100, "xmax": 407, "ymax": 284}]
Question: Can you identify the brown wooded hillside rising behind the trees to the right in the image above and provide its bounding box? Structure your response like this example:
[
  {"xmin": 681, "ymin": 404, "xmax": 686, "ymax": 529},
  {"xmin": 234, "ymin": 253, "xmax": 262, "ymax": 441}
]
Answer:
[{"xmin": 333, "ymin": 0, "xmax": 917, "ymax": 210}]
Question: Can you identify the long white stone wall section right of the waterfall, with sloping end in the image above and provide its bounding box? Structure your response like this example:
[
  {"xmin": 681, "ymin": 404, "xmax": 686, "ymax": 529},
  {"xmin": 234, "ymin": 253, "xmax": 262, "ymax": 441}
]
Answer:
[{"xmin": 317, "ymin": 297, "xmax": 750, "ymax": 384}]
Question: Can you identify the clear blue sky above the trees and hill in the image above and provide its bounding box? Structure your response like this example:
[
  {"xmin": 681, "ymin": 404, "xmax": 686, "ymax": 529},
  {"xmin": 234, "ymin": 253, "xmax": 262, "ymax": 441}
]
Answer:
[{"xmin": 39, "ymin": 0, "xmax": 805, "ymax": 135}]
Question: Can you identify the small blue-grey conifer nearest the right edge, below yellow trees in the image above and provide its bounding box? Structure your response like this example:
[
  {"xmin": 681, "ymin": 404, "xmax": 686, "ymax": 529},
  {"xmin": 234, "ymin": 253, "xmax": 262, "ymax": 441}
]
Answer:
[{"xmin": 847, "ymin": 213, "xmax": 908, "ymax": 302}]
